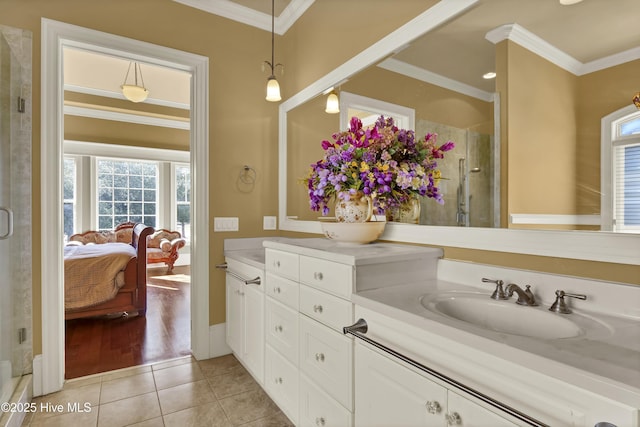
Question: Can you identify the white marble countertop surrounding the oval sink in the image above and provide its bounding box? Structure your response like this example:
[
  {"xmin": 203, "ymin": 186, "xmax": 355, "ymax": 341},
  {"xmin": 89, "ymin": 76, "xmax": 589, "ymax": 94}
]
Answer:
[{"xmin": 352, "ymin": 280, "xmax": 640, "ymax": 408}]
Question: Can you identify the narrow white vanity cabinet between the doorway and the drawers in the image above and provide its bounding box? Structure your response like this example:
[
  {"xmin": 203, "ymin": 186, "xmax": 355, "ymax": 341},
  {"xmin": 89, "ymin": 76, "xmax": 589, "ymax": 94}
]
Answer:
[{"xmin": 226, "ymin": 258, "xmax": 265, "ymax": 384}]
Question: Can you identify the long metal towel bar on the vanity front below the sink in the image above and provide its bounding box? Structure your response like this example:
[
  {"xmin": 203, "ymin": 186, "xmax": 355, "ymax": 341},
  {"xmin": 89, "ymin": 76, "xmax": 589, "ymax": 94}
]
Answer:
[{"xmin": 342, "ymin": 319, "xmax": 550, "ymax": 427}]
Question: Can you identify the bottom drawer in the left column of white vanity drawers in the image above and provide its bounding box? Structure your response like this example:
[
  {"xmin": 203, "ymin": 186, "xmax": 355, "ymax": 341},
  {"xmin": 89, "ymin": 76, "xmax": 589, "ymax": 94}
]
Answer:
[{"xmin": 264, "ymin": 345, "xmax": 298, "ymax": 424}]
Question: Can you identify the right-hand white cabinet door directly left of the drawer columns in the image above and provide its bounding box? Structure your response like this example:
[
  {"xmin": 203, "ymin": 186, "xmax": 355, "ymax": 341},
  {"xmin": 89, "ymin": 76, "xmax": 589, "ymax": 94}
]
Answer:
[{"xmin": 242, "ymin": 285, "xmax": 264, "ymax": 385}]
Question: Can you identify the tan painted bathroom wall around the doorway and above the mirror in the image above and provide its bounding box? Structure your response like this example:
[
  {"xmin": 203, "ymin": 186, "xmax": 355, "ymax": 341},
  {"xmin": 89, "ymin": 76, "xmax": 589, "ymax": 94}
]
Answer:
[{"xmin": 0, "ymin": 0, "xmax": 444, "ymax": 354}]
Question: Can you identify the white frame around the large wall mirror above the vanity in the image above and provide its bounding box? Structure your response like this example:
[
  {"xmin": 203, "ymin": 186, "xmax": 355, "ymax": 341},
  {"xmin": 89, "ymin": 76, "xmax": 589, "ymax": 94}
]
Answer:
[{"xmin": 278, "ymin": 0, "xmax": 640, "ymax": 265}]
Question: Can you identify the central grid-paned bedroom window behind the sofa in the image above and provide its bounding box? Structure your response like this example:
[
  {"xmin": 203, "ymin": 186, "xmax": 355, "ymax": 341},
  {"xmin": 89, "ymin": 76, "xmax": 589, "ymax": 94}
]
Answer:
[{"xmin": 97, "ymin": 159, "xmax": 158, "ymax": 230}]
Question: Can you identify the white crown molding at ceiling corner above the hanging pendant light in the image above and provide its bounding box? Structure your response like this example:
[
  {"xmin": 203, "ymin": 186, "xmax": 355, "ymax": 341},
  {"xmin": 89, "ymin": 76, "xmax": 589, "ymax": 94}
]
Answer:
[{"xmin": 173, "ymin": 0, "xmax": 315, "ymax": 35}]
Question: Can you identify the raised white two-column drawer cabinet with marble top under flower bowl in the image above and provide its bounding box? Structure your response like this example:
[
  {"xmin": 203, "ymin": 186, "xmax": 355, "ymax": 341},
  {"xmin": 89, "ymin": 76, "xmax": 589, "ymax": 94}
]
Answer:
[{"xmin": 265, "ymin": 239, "xmax": 442, "ymax": 427}]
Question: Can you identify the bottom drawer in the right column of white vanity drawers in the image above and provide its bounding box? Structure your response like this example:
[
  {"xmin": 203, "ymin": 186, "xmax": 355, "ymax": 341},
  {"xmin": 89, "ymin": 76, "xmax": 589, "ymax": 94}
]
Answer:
[{"xmin": 299, "ymin": 375, "xmax": 353, "ymax": 427}]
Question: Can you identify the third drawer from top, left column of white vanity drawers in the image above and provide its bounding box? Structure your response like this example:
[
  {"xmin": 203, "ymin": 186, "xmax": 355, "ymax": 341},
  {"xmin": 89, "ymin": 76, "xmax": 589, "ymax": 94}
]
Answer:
[{"xmin": 266, "ymin": 299, "xmax": 298, "ymax": 365}]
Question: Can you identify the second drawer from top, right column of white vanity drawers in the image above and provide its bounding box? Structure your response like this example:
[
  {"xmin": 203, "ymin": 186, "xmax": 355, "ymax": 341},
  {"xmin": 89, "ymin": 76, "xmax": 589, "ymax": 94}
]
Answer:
[{"xmin": 300, "ymin": 285, "xmax": 353, "ymax": 332}]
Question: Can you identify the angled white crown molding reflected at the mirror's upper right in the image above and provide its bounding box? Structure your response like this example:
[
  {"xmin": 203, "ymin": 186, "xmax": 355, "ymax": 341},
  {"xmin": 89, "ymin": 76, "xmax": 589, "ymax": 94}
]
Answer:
[{"xmin": 485, "ymin": 24, "xmax": 640, "ymax": 76}]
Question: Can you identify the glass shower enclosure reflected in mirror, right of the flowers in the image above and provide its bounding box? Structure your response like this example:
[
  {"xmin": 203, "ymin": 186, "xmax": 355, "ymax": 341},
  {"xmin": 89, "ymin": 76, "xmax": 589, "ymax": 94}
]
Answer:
[{"xmin": 416, "ymin": 120, "xmax": 499, "ymax": 227}]
